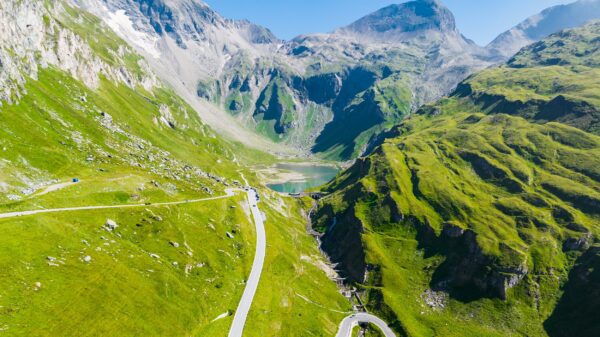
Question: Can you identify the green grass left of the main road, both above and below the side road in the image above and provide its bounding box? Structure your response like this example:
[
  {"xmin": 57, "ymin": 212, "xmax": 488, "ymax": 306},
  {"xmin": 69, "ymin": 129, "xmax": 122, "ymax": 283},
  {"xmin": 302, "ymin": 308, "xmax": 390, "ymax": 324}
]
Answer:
[{"xmin": 0, "ymin": 63, "xmax": 254, "ymax": 336}]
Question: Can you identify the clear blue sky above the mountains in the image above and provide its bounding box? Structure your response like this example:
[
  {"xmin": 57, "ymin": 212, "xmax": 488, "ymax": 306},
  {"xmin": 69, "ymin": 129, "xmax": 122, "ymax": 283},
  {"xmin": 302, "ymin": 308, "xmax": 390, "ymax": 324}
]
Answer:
[{"xmin": 204, "ymin": 0, "xmax": 574, "ymax": 45}]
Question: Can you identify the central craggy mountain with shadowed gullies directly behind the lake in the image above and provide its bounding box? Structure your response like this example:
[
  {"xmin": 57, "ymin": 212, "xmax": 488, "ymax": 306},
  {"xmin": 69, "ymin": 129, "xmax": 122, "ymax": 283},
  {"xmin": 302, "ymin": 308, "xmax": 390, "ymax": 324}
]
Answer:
[{"xmin": 197, "ymin": 1, "xmax": 494, "ymax": 160}]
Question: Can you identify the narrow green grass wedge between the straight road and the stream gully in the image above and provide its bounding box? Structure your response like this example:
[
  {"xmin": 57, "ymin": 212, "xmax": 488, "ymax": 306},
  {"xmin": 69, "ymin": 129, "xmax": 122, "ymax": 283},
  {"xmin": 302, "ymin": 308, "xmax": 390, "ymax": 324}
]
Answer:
[{"xmin": 245, "ymin": 191, "xmax": 351, "ymax": 337}]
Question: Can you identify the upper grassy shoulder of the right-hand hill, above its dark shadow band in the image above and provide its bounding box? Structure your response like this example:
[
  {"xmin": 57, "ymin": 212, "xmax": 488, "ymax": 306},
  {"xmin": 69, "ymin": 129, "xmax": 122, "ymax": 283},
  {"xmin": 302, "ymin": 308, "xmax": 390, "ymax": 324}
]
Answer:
[{"xmin": 455, "ymin": 22, "xmax": 600, "ymax": 134}]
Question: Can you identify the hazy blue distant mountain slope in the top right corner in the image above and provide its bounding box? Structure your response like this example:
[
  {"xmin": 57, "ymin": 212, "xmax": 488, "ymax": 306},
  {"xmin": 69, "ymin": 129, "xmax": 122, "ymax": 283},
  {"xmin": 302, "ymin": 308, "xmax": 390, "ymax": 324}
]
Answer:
[{"xmin": 487, "ymin": 0, "xmax": 600, "ymax": 58}]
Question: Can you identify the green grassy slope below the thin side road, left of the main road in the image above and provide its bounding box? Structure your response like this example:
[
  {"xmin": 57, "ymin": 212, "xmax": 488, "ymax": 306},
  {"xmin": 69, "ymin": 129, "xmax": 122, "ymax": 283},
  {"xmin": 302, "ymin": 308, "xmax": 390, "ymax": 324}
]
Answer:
[{"xmin": 0, "ymin": 197, "xmax": 254, "ymax": 336}]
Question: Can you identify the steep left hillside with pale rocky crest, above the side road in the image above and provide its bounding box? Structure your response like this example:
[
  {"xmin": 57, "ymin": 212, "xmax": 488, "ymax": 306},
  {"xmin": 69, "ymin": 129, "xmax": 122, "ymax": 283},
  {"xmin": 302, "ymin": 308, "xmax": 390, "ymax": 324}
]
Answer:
[{"xmin": 0, "ymin": 1, "xmax": 232, "ymax": 201}]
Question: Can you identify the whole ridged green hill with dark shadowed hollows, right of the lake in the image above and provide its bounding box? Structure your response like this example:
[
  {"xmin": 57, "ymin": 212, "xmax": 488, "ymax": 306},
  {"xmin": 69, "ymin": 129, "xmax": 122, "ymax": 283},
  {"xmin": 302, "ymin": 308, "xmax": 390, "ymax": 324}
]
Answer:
[{"xmin": 314, "ymin": 23, "xmax": 600, "ymax": 336}]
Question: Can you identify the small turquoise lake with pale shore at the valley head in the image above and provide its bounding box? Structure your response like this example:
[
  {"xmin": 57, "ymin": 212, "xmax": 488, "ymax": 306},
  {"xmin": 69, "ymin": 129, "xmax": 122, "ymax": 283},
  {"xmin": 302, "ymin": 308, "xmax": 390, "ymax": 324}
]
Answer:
[{"xmin": 267, "ymin": 164, "xmax": 339, "ymax": 193}]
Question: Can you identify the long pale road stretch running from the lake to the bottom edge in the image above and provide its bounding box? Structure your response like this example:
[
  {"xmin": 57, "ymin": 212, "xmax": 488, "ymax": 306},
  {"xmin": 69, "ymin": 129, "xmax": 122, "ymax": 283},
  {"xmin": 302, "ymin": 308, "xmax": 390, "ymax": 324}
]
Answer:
[{"xmin": 228, "ymin": 189, "xmax": 267, "ymax": 337}]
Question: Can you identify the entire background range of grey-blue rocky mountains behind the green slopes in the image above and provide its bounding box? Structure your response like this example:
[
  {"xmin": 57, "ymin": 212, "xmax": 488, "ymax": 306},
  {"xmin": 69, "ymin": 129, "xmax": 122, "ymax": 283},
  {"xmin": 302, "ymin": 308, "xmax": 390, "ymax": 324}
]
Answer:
[{"xmin": 74, "ymin": 0, "xmax": 597, "ymax": 160}]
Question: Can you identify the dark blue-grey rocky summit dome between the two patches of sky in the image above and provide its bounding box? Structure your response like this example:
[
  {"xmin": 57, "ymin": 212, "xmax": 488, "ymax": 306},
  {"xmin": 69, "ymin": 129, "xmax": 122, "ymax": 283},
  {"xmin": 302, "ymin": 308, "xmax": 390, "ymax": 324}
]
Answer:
[{"xmin": 339, "ymin": 0, "xmax": 456, "ymax": 38}]
